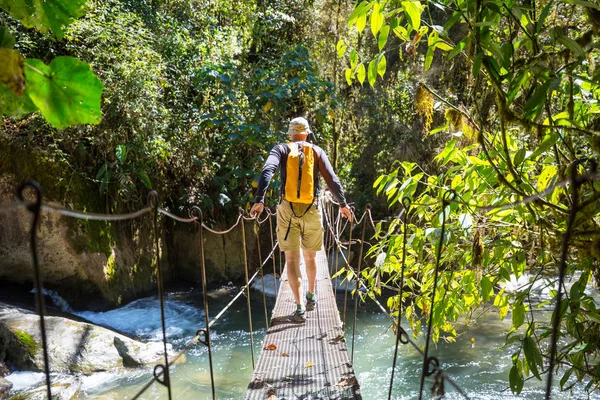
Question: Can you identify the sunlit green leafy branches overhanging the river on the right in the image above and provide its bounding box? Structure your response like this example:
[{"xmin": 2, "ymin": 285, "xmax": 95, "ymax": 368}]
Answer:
[{"xmin": 337, "ymin": 0, "xmax": 600, "ymax": 393}]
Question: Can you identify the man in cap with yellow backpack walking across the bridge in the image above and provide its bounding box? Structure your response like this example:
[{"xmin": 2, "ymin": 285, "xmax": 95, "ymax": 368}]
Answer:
[{"xmin": 250, "ymin": 117, "xmax": 352, "ymax": 322}]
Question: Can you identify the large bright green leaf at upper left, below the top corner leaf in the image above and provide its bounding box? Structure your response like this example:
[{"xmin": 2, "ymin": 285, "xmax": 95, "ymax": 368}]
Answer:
[{"xmin": 25, "ymin": 56, "xmax": 102, "ymax": 129}]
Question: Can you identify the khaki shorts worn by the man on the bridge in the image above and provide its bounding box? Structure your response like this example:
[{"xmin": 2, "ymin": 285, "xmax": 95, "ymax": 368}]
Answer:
[{"xmin": 277, "ymin": 200, "xmax": 323, "ymax": 251}]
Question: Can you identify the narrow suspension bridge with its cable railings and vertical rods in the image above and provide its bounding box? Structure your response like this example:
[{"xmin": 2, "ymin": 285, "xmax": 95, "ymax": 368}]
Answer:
[{"xmin": 0, "ymin": 162, "xmax": 599, "ymax": 400}]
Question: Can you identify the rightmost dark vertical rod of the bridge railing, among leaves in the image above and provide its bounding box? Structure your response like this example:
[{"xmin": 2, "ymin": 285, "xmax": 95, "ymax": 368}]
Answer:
[{"xmin": 545, "ymin": 160, "xmax": 583, "ymax": 399}]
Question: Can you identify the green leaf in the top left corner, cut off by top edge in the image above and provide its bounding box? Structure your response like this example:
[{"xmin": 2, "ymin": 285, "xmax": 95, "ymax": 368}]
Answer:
[{"xmin": 0, "ymin": 0, "xmax": 86, "ymax": 39}]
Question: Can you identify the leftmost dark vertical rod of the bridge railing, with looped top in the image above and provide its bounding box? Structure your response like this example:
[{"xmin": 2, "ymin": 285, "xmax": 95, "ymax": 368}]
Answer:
[{"xmin": 18, "ymin": 181, "xmax": 52, "ymax": 399}]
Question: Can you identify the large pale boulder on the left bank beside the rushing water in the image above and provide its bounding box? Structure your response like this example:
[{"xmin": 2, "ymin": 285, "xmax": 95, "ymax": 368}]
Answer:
[{"xmin": 0, "ymin": 304, "xmax": 184, "ymax": 374}]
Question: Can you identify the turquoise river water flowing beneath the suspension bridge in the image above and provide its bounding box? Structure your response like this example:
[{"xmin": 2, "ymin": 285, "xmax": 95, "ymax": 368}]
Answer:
[{"xmin": 5, "ymin": 282, "xmax": 600, "ymax": 400}]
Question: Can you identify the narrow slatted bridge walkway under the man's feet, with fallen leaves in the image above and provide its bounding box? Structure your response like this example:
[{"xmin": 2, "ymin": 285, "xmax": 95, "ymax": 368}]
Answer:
[{"xmin": 246, "ymin": 251, "xmax": 362, "ymax": 400}]
